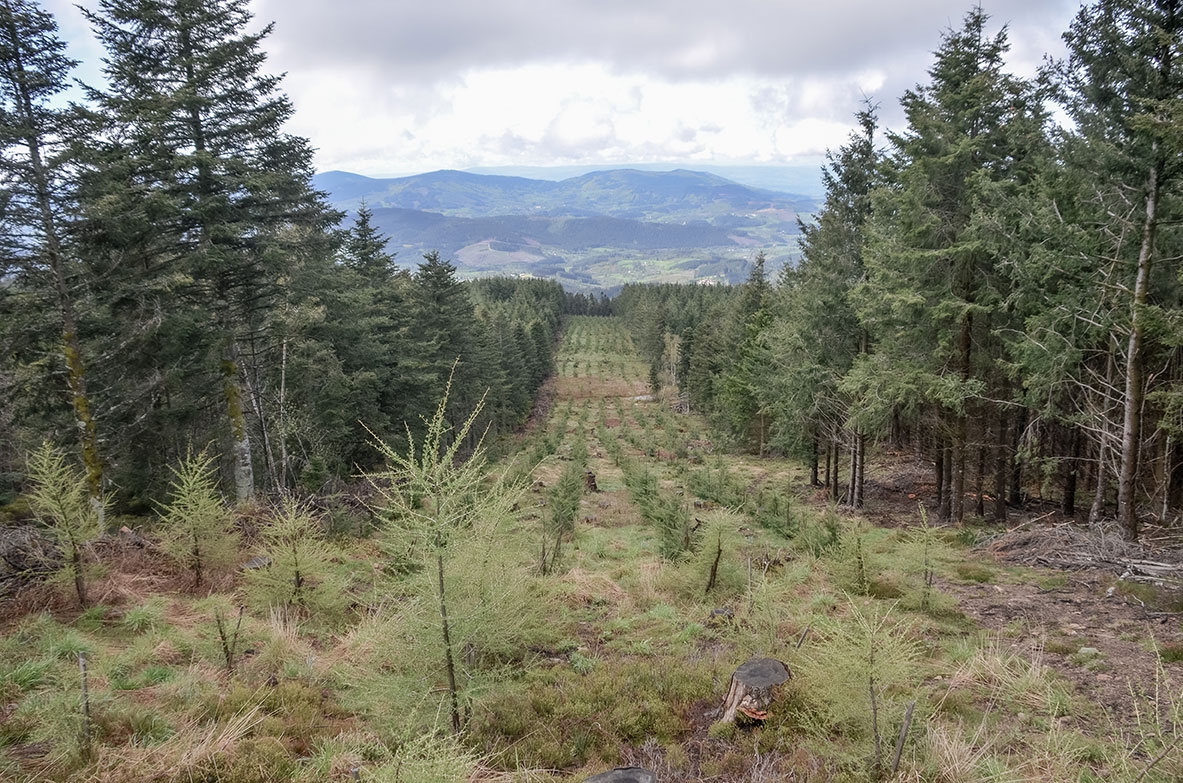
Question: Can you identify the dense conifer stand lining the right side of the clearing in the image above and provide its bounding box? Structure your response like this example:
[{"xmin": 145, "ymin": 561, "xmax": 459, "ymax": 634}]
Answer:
[{"xmin": 618, "ymin": 0, "xmax": 1183, "ymax": 538}]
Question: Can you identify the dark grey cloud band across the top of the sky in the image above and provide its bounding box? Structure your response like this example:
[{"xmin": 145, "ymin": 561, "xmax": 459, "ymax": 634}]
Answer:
[{"xmin": 253, "ymin": 0, "xmax": 1074, "ymax": 80}]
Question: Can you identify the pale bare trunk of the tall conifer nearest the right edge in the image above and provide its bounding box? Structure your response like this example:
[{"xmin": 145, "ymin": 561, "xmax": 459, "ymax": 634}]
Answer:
[{"xmin": 1117, "ymin": 153, "xmax": 1159, "ymax": 541}]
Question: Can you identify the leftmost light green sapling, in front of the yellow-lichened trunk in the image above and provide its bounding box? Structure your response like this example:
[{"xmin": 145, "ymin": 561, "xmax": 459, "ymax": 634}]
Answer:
[{"xmin": 25, "ymin": 442, "xmax": 103, "ymax": 607}]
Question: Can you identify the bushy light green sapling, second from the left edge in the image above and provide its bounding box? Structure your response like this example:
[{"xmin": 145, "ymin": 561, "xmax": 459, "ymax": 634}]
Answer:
[{"xmin": 160, "ymin": 452, "xmax": 239, "ymax": 588}]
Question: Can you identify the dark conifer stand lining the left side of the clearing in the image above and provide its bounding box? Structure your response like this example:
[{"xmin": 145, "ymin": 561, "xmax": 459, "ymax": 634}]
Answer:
[{"xmin": 0, "ymin": 0, "xmax": 565, "ymax": 512}]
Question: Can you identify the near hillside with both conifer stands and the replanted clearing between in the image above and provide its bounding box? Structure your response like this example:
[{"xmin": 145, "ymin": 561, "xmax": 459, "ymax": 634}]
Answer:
[{"xmin": 0, "ymin": 0, "xmax": 1183, "ymax": 783}]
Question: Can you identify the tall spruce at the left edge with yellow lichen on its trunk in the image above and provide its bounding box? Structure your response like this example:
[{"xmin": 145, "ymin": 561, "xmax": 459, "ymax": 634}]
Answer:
[{"xmin": 0, "ymin": 0, "xmax": 103, "ymax": 509}]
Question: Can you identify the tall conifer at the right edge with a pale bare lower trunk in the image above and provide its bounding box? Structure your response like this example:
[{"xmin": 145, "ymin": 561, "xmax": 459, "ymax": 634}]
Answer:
[{"xmin": 1059, "ymin": 0, "xmax": 1183, "ymax": 539}]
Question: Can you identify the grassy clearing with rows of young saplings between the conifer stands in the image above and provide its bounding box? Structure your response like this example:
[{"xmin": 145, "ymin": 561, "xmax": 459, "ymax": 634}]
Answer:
[{"xmin": 0, "ymin": 318, "xmax": 1183, "ymax": 783}]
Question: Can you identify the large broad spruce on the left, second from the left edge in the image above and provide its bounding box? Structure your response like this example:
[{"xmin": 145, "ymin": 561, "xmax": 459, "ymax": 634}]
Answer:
[{"xmin": 81, "ymin": 0, "xmax": 329, "ymax": 500}]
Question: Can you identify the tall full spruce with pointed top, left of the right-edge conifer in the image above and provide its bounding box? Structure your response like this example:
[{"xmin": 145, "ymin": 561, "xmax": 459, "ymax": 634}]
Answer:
[{"xmin": 859, "ymin": 7, "xmax": 1045, "ymax": 520}]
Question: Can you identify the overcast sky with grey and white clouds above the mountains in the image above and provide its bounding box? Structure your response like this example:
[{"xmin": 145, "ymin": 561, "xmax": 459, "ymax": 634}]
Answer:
[{"xmin": 44, "ymin": 0, "xmax": 1079, "ymax": 176}]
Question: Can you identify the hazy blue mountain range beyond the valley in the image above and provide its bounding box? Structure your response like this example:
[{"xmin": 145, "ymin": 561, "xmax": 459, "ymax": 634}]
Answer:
[{"xmin": 313, "ymin": 169, "xmax": 815, "ymax": 287}]
